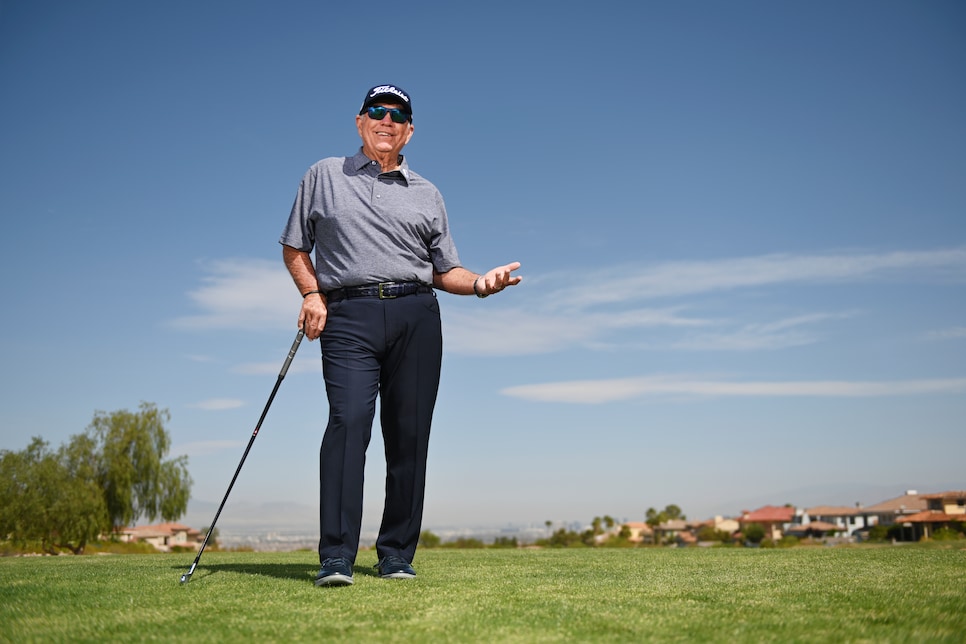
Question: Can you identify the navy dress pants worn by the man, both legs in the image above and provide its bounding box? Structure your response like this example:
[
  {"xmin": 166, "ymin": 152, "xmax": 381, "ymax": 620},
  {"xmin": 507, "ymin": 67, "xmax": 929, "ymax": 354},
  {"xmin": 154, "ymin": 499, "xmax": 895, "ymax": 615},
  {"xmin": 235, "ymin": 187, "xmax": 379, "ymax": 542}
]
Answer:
[{"xmin": 319, "ymin": 292, "xmax": 443, "ymax": 562}]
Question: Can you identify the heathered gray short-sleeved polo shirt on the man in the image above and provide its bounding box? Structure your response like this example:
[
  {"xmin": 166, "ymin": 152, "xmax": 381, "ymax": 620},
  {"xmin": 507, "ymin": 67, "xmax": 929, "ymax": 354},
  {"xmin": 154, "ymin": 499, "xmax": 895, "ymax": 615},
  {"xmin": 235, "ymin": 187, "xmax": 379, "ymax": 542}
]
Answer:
[{"xmin": 279, "ymin": 149, "xmax": 460, "ymax": 291}]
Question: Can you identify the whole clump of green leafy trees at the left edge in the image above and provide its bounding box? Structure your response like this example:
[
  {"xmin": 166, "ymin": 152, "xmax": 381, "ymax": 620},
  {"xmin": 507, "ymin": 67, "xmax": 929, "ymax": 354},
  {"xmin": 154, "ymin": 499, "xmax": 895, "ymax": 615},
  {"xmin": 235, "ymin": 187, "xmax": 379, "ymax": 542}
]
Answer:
[{"xmin": 0, "ymin": 403, "xmax": 191, "ymax": 554}]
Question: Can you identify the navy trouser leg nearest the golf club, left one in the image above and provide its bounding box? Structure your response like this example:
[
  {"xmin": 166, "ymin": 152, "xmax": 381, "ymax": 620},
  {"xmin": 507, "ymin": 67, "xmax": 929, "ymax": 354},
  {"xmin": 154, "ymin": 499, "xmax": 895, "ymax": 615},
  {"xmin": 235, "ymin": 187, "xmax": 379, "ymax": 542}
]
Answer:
[{"xmin": 319, "ymin": 300, "xmax": 384, "ymax": 562}]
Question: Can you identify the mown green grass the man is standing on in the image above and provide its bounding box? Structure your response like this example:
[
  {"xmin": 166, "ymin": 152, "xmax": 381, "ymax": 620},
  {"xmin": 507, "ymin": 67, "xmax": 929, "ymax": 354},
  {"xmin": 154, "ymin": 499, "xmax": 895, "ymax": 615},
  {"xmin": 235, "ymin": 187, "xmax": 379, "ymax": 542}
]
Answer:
[{"xmin": 0, "ymin": 544, "xmax": 966, "ymax": 642}]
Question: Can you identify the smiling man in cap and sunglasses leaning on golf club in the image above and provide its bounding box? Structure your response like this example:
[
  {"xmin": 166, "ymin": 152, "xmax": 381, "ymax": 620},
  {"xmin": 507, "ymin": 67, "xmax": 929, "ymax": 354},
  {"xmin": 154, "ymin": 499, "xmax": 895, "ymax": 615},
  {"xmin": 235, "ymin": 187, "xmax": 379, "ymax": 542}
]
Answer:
[{"xmin": 279, "ymin": 85, "xmax": 521, "ymax": 586}]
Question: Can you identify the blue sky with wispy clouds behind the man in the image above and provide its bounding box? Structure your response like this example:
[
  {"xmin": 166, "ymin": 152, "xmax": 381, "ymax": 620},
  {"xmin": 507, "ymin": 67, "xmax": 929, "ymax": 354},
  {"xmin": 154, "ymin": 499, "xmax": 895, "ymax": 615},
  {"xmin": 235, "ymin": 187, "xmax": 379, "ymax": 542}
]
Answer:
[{"xmin": 0, "ymin": 0, "xmax": 966, "ymax": 528}]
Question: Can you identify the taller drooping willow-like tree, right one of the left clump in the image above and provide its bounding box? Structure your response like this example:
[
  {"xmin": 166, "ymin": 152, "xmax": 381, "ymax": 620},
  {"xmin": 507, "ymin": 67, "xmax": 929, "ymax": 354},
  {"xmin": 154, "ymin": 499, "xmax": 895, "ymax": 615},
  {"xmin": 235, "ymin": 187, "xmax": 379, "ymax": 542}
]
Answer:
[{"xmin": 87, "ymin": 403, "xmax": 192, "ymax": 527}]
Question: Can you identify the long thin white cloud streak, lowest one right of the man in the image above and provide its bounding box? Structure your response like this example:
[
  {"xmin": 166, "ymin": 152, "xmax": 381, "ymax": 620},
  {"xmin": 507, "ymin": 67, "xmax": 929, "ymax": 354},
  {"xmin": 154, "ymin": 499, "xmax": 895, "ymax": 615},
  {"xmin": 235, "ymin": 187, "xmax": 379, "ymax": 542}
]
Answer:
[{"xmin": 501, "ymin": 376, "xmax": 966, "ymax": 404}]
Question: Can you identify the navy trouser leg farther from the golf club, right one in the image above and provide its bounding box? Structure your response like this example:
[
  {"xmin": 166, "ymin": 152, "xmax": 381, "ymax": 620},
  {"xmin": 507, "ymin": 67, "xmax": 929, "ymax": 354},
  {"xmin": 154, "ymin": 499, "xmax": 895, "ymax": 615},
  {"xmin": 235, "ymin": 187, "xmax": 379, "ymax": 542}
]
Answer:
[{"xmin": 376, "ymin": 293, "xmax": 443, "ymax": 562}]
